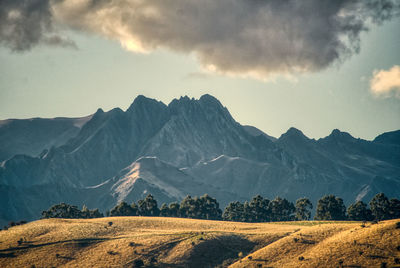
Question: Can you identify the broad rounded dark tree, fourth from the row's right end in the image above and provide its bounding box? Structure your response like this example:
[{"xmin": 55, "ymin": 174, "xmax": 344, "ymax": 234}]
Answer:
[{"xmin": 314, "ymin": 195, "xmax": 346, "ymax": 220}]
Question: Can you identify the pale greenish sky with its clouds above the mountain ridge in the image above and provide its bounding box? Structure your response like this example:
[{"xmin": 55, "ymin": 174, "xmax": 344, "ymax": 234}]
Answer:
[{"xmin": 0, "ymin": 0, "xmax": 400, "ymax": 139}]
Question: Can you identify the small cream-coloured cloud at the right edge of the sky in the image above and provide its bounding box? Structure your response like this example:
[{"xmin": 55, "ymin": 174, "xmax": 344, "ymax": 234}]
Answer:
[{"xmin": 370, "ymin": 65, "xmax": 400, "ymax": 98}]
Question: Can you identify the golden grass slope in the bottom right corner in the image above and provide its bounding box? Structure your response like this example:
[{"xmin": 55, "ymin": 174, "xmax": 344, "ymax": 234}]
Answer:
[{"xmin": 231, "ymin": 220, "xmax": 400, "ymax": 267}]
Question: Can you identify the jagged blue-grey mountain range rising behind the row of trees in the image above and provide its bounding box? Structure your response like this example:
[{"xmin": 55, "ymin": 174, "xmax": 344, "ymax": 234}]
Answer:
[{"xmin": 0, "ymin": 95, "xmax": 400, "ymax": 224}]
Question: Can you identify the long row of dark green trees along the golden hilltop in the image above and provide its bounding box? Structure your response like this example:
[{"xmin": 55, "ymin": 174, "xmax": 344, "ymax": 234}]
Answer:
[{"xmin": 42, "ymin": 193, "xmax": 400, "ymax": 222}]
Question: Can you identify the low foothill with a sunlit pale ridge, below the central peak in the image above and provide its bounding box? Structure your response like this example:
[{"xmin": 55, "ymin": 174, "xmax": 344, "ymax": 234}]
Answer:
[{"xmin": 86, "ymin": 157, "xmax": 244, "ymax": 208}]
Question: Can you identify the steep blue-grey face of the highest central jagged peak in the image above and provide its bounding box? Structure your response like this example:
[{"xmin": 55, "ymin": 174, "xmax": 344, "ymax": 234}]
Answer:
[{"xmin": 141, "ymin": 95, "xmax": 276, "ymax": 167}]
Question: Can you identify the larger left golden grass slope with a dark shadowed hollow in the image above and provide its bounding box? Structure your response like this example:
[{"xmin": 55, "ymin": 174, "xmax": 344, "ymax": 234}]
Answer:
[{"xmin": 0, "ymin": 217, "xmax": 307, "ymax": 267}]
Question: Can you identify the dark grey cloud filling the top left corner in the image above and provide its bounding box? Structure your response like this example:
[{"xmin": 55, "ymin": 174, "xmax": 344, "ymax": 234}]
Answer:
[{"xmin": 0, "ymin": 0, "xmax": 76, "ymax": 51}]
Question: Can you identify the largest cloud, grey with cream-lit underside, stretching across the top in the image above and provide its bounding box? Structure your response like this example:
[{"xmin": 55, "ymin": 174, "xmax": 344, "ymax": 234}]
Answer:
[{"xmin": 0, "ymin": 0, "xmax": 400, "ymax": 79}]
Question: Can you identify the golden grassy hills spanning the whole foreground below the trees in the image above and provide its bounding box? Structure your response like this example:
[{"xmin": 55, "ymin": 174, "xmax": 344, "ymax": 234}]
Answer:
[{"xmin": 0, "ymin": 217, "xmax": 400, "ymax": 267}]
